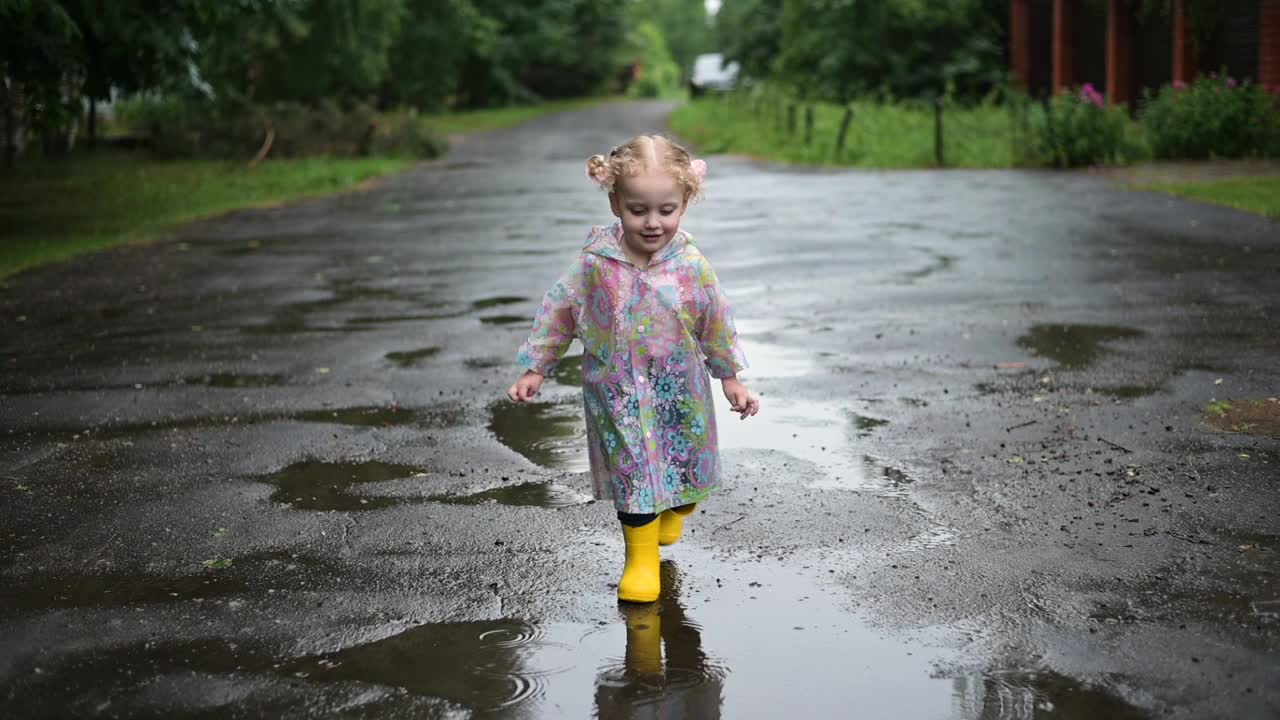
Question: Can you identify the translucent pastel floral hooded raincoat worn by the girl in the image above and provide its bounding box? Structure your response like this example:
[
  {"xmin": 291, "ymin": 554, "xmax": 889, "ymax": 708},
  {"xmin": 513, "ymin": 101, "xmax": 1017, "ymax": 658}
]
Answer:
[{"xmin": 516, "ymin": 223, "xmax": 746, "ymax": 512}]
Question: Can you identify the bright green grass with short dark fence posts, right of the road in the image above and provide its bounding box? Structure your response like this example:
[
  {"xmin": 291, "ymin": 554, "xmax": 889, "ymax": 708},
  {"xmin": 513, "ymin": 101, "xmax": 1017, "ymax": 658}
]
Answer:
[{"xmin": 669, "ymin": 96, "xmax": 1014, "ymax": 169}]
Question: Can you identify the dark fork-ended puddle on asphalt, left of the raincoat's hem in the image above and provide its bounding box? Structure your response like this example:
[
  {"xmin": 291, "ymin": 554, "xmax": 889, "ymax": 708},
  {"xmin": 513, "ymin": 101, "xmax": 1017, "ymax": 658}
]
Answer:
[{"xmin": 259, "ymin": 460, "xmax": 424, "ymax": 511}]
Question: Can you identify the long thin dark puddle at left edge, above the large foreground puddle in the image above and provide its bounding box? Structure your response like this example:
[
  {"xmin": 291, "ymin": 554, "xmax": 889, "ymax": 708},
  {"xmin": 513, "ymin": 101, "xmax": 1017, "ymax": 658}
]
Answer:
[{"xmin": 0, "ymin": 570, "xmax": 248, "ymax": 611}]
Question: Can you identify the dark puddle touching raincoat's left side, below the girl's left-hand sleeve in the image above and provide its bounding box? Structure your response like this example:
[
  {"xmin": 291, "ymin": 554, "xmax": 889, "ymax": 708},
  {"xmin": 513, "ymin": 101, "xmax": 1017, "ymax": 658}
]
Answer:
[{"xmin": 489, "ymin": 398, "xmax": 588, "ymax": 473}]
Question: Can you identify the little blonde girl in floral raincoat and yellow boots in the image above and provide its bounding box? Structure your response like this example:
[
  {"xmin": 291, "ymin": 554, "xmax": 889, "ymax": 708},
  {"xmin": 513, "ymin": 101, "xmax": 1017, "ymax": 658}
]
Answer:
[{"xmin": 507, "ymin": 136, "xmax": 760, "ymax": 602}]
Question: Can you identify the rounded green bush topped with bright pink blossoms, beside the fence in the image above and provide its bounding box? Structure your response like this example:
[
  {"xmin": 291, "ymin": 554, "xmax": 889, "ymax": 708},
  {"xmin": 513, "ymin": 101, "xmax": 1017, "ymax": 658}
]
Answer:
[{"xmin": 1034, "ymin": 83, "xmax": 1133, "ymax": 168}]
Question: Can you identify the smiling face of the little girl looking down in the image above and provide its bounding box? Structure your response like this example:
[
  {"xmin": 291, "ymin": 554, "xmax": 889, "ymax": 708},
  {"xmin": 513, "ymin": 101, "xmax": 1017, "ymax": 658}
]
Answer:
[{"xmin": 609, "ymin": 168, "xmax": 685, "ymax": 265}]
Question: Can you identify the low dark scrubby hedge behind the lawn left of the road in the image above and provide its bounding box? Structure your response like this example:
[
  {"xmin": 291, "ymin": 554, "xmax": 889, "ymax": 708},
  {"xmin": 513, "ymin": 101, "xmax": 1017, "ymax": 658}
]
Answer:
[{"xmin": 116, "ymin": 99, "xmax": 445, "ymax": 158}]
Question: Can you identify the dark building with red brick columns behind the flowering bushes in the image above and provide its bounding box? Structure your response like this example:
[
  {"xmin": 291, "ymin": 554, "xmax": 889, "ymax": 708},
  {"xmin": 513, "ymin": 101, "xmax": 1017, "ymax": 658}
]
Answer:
[{"xmin": 1009, "ymin": 0, "xmax": 1280, "ymax": 104}]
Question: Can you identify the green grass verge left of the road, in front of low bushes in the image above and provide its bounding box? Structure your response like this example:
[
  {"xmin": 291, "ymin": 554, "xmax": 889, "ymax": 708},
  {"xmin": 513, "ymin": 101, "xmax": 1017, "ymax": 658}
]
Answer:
[{"xmin": 0, "ymin": 151, "xmax": 413, "ymax": 277}]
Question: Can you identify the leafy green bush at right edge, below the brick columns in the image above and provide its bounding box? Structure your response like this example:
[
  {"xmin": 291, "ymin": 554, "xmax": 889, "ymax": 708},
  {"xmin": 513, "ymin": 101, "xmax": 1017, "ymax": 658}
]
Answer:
[{"xmin": 1142, "ymin": 73, "xmax": 1280, "ymax": 159}]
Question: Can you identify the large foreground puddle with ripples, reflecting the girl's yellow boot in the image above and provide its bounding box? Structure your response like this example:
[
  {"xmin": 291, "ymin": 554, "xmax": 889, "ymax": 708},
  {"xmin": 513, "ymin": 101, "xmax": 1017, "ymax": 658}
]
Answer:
[{"xmin": 7, "ymin": 548, "xmax": 1147, "ymax": 720}]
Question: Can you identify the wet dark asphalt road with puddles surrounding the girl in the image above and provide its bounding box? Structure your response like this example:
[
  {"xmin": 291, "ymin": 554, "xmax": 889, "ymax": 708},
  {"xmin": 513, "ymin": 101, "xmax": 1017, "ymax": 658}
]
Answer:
[{"xmin": 0, "ymin": 104, "xmax": 1280, "ymax": 720}]
